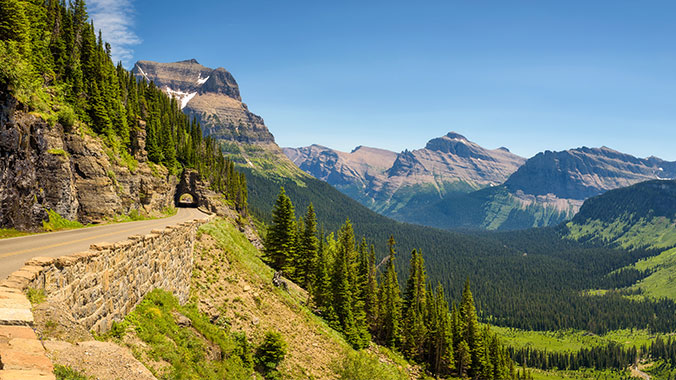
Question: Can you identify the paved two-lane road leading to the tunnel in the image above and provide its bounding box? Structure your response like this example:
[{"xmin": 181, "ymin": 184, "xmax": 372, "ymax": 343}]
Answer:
[{"xmin": 0, "ymin": 208, "xmax": 206, "ymax": 280}]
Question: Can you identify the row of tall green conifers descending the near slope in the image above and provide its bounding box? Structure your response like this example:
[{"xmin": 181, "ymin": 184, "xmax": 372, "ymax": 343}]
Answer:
[{"xmin": 264, "ymin": 187, "xmax": 530, "ymax": 379}]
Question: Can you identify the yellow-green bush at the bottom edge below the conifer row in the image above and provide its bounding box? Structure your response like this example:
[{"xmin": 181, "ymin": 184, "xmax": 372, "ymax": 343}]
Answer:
[{"xmin": 337, "ymin": 351, "xmax": 408, "ymax": 380}]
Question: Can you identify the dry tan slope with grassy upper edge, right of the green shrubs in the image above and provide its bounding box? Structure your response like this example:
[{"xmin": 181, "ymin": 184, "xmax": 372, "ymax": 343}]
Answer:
[{"xmin": 192, "ymin": 220, "xmax": 413, "ymax": 379}]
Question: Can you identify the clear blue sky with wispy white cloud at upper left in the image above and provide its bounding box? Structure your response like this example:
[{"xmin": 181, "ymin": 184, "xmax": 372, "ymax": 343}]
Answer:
[{"xmin": 93, "ymin": 0, "xmax": 676, "ymax": 160}]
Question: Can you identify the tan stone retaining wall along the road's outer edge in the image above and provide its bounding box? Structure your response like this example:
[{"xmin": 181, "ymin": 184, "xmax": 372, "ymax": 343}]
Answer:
[{"xmin": 0, "ymin": 215, "xmax": 208, "ymax": 380}]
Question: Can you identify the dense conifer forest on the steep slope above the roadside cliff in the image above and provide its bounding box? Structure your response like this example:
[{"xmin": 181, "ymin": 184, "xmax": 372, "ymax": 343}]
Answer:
[{"xmin": 0, "ymin": 0, "xmax": 247, "ymax": 211}]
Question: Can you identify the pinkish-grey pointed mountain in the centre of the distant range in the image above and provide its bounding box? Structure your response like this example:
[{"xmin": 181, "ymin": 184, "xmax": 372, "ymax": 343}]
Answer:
[{"xmin": 284, "ymin": 132, "xmax": 525, "ymax": 220}]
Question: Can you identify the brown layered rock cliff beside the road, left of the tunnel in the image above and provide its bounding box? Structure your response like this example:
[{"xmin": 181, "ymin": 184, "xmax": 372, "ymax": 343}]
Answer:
[{"xmin": 0, "ymin": 87, "xmax": 177, "ymax": 229}]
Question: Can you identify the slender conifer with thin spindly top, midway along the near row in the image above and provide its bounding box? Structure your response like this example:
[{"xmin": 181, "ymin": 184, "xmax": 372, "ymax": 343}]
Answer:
[{"xmin": 378, "ymin": 236, "xmax": 401, "ymax": 347}]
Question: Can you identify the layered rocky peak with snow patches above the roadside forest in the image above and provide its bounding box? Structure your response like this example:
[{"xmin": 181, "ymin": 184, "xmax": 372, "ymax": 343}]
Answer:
[{"xmin": 132, "ymin": 59, "xmax": 274, "ymax": 144}]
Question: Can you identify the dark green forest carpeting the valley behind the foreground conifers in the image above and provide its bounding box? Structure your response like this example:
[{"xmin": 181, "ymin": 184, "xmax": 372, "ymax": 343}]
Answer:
[{"xmin": 242, "ymin": 168, "xmax": 676, "ymax": 333}]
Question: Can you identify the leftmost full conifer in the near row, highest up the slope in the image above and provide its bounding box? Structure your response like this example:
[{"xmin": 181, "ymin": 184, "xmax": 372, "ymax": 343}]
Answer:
[{"xmin": 264, "ymin": 187, "xmax": 296, "ymax": 273}]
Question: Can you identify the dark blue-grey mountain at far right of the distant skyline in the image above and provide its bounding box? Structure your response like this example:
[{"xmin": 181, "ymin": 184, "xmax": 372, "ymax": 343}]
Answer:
[{"xmin": 505, "ymin": 147, "xmax": 676, "ymax": 201}]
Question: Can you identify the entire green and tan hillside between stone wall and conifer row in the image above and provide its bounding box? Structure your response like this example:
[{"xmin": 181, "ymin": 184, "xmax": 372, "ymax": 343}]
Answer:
[{"xmin": 102, "ymin": 220, "xmax": 412, "ymax": 379}]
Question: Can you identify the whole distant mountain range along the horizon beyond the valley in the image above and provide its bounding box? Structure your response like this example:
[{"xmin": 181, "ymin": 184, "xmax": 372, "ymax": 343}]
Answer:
[{"xmin": 283, "ymin": 137, "xmax": 676, "ymax": 230}]
